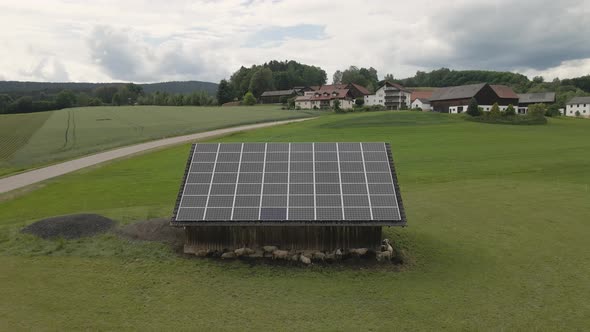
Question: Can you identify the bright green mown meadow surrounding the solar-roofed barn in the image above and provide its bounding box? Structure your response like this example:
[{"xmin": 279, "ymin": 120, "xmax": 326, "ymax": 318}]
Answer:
[{"xmin": 0, "ymin": 112, "xmax": 590, "ymax": 331}]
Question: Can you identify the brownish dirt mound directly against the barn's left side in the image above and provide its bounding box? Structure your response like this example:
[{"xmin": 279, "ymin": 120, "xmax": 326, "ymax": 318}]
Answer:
[{"xmin": 118, "ymin": 218, "xmax": 184, "ymax": 246}]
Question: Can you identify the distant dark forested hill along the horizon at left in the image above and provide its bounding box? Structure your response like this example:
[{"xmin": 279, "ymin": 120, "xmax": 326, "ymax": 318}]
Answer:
[{"xmin": 0, "ymin": 81, "xmax": 217, "ymax": 96}]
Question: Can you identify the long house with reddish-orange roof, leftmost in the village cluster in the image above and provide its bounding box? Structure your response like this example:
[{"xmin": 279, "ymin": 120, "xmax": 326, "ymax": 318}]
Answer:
[{"xmin": 295, "ymin": 87, "xmax": 355, "ymax": 109}]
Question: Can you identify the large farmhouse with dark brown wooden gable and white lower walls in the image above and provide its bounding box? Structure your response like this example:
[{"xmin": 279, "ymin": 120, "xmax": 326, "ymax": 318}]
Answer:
[{"xmin": 430, "ymin": 83, "xmax": 518, "ymax": 113}]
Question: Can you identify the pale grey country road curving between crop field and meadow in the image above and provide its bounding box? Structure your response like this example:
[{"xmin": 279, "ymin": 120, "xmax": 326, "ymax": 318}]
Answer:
[{"xmin": 0, "ymin": 118, "xmax": 313, "ymax": 194}]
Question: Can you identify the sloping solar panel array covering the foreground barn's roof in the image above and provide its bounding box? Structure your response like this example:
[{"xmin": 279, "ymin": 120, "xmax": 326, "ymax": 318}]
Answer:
[{"xmin": 172, "ymin": 142, "xmax": 406, "ymax": 226}]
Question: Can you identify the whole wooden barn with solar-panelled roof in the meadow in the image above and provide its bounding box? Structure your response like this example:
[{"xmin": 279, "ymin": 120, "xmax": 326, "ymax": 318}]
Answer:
[{"xmin": 171, "ymin": 143, "xmax": 406, "ymax": 253}]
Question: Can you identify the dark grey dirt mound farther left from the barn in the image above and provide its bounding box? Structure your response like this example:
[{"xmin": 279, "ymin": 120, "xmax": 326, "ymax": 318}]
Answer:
[{"xmin": 21, "ymin": 214, "xmax": 115, "ymax": 239}]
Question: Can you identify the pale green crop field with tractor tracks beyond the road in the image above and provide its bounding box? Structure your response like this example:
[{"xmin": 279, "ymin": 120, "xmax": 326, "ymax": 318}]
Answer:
[{"xmin": 0, "ymin": 106, "xmax": 310, "ymax": 176}]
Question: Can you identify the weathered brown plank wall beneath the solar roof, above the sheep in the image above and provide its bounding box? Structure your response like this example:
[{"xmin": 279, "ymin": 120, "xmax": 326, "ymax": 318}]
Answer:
[{"xmin": 185, "ymin": 226, "xmax": 381, "ymax": 252}]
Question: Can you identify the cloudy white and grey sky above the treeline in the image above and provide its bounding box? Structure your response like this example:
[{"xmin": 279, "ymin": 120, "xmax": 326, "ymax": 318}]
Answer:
[{"xmin": 0, "ymin": 0, "xmax": 590, "ymax": 82}]
